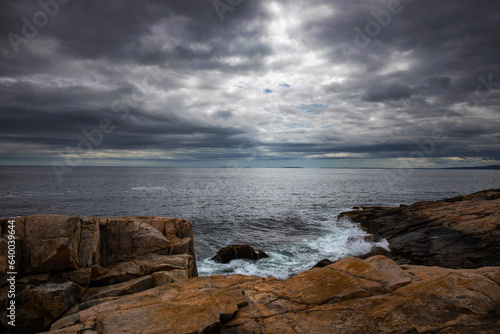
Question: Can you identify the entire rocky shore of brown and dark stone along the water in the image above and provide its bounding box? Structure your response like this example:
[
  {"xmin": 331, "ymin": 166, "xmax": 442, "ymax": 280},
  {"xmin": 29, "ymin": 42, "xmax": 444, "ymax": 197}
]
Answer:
[{"xmin": 0, "ymin": 189, "xmax": 500, "ymax": 334}]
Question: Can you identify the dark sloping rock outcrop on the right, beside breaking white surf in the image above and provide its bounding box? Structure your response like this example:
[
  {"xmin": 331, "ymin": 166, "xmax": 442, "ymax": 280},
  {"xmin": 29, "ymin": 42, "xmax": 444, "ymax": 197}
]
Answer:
[{"xmin": 339, "ymin": 189, "xmax": 500, "ymax": 268}]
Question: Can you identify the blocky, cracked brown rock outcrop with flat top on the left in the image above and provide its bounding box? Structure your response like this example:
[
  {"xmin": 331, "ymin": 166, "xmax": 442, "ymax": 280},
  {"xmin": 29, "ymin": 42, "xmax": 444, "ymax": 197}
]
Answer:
[{"xmin": 0, "ymin": 215, "xmax": 198, "ymax": 333}]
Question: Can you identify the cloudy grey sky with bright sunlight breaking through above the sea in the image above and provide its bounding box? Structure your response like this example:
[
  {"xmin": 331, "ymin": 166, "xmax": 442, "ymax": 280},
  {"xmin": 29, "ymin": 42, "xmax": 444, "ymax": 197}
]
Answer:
[{"xmin": 0, "ymin": 0, "xmax": 500, "ymax": 169}]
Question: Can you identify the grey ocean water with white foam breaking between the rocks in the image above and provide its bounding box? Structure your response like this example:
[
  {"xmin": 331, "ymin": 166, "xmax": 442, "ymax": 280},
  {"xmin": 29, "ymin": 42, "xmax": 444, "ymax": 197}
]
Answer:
[{"xmin": 0, "ymin": 167, "xmax": 500, "ymax": 278}]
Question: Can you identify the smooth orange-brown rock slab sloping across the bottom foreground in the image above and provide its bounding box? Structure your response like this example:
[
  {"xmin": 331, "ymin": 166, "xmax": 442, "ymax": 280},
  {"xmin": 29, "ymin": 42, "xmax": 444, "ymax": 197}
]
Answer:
[{"xmin": 42, "ymin": 256, "xmax": 500, "ymax": 334}]
